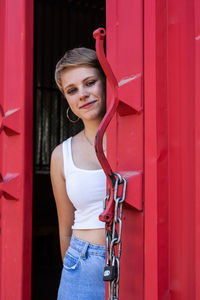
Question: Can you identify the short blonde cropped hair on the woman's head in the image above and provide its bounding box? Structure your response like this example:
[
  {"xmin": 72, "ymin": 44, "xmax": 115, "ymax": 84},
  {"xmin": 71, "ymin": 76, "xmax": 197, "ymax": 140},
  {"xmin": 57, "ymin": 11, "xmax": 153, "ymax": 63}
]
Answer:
[{"xmin": 55, "ymin": 47, "xmax": 105, "ymax": 93}]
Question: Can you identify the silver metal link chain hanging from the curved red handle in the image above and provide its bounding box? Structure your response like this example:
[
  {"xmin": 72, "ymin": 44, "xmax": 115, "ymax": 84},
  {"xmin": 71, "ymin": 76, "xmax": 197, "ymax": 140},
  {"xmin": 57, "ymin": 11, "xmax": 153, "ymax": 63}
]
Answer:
[{"xmin": 104, "ymin": 173, "xmax": 127, "ymax": 300}]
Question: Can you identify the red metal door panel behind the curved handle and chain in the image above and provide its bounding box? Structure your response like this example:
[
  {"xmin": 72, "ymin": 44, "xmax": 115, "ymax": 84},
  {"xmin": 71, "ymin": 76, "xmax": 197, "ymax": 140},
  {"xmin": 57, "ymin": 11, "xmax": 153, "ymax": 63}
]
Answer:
[{"xmin": 106, "ymin": 0, "xmax": 144, "ymax": 300}]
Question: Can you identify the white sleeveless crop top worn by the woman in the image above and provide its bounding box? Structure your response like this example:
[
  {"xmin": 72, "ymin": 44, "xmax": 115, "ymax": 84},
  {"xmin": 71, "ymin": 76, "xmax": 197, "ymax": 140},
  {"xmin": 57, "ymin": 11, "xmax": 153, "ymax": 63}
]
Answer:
[{"xmin": 63, "ymin": 137, "xmax": 106, "ymax": 229}]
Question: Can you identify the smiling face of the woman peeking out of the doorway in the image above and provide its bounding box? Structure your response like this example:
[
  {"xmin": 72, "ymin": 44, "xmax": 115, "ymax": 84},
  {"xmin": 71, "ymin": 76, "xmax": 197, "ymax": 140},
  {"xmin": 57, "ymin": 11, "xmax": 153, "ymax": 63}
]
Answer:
[{"xmin": 61, "ymin": 66, "xmax": 106, "ymax": 122}]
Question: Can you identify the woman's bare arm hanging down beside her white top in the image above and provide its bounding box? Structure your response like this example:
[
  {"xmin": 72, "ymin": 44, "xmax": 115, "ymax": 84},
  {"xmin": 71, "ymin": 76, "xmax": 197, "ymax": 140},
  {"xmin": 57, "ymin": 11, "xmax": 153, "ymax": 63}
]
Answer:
[{"xmin": 50, "ymin": 144, "xmax": 75, "ymax": 259}]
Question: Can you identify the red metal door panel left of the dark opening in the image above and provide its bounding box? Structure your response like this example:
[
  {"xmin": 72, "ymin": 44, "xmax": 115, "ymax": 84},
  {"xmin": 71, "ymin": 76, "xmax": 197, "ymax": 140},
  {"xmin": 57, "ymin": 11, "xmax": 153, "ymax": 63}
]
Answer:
[{"xmin": 0, "ymin": 0, "xmax": 33, "ymax": 300}]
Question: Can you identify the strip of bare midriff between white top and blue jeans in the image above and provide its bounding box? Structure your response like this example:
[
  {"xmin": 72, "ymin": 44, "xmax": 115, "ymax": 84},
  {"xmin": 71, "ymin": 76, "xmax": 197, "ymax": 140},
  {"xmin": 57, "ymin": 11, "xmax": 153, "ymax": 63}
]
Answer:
[{"xmin": 73, "ymin": 228, "xmax": 105, "ymax": 245}]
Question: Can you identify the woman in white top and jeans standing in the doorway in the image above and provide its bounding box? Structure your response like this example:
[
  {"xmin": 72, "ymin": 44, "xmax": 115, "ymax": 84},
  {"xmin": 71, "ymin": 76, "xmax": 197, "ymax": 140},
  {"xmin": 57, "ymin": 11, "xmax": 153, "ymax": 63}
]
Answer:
[{"xmin": 51, "ymin": 48, "xmax": 106, "ymax": 300}]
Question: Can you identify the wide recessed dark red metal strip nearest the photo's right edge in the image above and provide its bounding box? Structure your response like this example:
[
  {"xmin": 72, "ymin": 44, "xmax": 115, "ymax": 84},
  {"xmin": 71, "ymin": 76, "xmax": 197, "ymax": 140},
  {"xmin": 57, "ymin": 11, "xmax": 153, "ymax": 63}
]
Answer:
[{"xmin": 168, "ymin": 1, "xmax": 199, "ymax": 300}]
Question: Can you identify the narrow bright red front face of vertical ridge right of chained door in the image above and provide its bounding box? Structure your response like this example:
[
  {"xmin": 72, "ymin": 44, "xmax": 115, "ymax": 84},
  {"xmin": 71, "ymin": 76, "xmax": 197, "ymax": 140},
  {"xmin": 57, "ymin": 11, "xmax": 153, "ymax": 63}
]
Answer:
[{"xmin": 144, "ymin": 0, "xmax": 158, "ymax": 300}]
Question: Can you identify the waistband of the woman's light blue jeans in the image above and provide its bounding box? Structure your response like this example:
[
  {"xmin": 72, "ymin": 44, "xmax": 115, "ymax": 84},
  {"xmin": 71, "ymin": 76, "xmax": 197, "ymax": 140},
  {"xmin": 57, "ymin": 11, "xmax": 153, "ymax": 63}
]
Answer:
[{"xmin": 69, "ymin": 235, "xmax": 106, "ymax": 258}]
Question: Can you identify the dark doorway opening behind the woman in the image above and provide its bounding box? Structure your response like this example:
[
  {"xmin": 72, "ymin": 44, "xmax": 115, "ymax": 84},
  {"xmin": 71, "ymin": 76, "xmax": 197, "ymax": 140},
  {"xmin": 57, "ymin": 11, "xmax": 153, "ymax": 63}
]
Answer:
[{"xmin": 32, "ymin": 0, "xmax": 106, "ymax": 300}]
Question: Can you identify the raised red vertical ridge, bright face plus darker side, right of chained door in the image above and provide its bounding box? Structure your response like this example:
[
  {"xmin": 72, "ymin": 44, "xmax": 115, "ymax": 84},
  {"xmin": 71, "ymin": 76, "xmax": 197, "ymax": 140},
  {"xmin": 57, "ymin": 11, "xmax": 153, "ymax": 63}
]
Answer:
[{"xmin": 144, "ymin": 1, "xmax": 169, "ymax": 300}]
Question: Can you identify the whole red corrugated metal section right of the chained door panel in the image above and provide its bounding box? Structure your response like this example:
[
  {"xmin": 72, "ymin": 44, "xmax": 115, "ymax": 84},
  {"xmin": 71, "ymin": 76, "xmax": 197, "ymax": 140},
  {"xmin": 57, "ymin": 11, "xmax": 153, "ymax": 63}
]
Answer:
[{"xmin": 144, "ymin": 0, "xmax": 200, "ymax": 300}]
